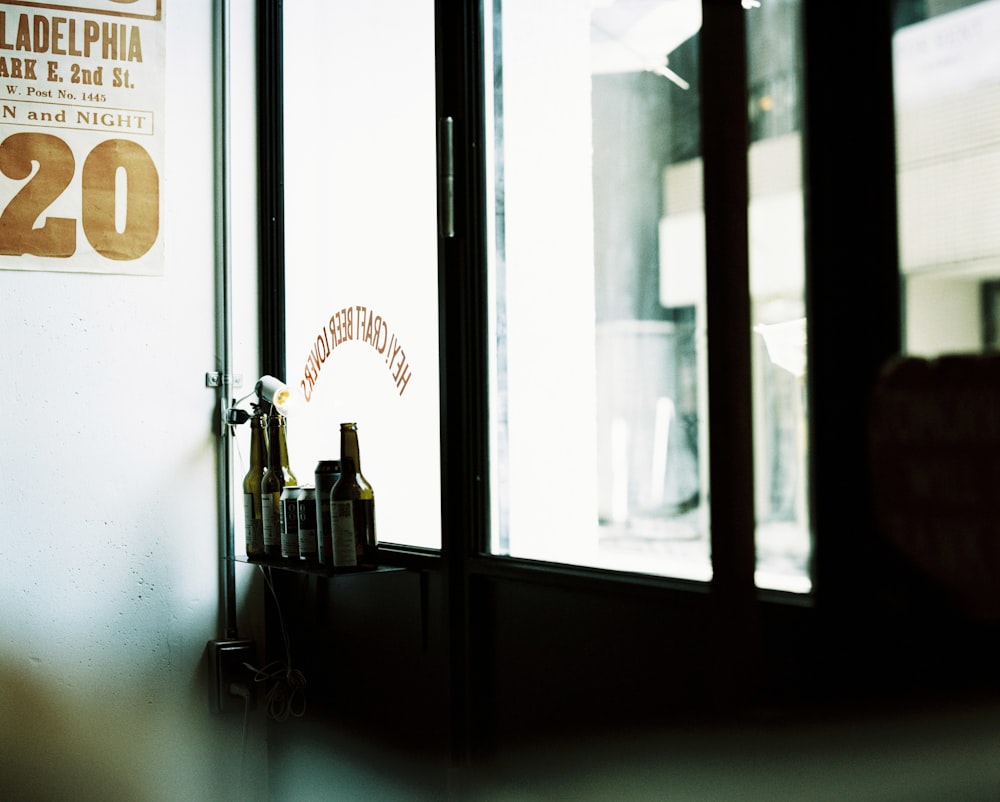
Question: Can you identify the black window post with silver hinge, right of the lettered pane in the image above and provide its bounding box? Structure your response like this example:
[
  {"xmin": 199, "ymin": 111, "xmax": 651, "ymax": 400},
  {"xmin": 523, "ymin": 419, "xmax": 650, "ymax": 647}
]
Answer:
[{"xmin": 435, "ymin": 2, "xmax": 489, "ymax": 765}]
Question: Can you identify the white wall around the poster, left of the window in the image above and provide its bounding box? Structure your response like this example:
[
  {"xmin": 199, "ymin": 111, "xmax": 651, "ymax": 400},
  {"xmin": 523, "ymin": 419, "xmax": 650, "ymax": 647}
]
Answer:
[{"xmin": 0, "ymin": 0, "xmax": 266, "ymax": 800}]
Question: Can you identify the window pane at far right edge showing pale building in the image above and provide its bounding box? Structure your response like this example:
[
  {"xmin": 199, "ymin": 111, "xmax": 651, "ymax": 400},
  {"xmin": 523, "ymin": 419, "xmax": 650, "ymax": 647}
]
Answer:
[{"xmin": 893, "ymin": 0, "xmax": 1000, "ymax": 356}]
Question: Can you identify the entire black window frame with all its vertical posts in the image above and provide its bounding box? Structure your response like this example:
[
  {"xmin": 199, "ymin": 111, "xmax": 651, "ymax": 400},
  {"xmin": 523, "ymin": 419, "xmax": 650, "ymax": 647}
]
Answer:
[{"xmin": 257, "ymin": 0, "xmax": 900, "ymax": 759}]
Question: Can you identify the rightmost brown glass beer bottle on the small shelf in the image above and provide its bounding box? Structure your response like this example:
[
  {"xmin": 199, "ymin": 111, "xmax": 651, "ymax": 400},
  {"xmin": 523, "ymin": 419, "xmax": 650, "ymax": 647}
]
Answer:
[{"xmin": 330, "ymin": 423, "xmax": 378, "ymax": 567}]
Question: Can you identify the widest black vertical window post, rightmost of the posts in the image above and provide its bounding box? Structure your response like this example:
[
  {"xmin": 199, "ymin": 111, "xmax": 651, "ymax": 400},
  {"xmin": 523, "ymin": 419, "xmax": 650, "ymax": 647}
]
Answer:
[{"xmin": 803, "ymin": 1, "xmax": 900, "ymax": 664}]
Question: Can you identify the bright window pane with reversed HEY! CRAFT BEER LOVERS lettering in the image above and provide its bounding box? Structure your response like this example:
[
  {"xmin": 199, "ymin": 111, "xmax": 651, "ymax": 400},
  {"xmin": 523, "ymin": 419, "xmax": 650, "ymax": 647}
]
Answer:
[{"xmin": 283, "ymin": 0, "xmax": 441, "ymax": 548}]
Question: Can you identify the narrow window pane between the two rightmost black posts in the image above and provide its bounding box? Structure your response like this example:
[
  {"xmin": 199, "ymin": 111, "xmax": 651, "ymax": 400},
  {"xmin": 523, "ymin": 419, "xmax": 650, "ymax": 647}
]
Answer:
[{"xmin": 744, "ymin": 0, "xmax": 812, "ymax": 592}]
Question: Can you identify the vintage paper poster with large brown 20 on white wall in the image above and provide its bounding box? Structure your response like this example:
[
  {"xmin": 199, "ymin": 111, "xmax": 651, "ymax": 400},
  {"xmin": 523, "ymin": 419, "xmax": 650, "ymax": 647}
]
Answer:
[{"xmin": 0, "ymin": 0, "xmax": 166, "ymax": 275}]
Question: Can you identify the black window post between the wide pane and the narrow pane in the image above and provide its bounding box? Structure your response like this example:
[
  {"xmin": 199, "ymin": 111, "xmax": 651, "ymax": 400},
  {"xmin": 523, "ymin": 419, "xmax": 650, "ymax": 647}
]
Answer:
[{"xmin": 701, "ymin": 0, "xmax": 756, "ymax": 691}]
